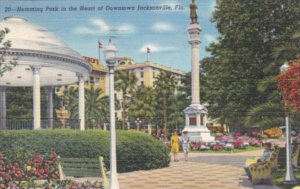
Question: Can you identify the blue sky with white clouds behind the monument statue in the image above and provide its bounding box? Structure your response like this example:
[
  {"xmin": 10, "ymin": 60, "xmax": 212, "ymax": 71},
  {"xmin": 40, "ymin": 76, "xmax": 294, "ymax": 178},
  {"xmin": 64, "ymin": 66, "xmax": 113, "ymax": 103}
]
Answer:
[{"xmin": 0, "ymin": 0, "xmax": 218, "ymax": 71}]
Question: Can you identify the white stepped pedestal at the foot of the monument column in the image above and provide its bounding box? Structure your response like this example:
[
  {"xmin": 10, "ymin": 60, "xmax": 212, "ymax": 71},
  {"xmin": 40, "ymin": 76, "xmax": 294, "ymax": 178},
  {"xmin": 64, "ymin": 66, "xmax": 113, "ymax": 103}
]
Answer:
[{"xmin": 183, "ymin": 104, "xmax": 215, "ymax": 142}]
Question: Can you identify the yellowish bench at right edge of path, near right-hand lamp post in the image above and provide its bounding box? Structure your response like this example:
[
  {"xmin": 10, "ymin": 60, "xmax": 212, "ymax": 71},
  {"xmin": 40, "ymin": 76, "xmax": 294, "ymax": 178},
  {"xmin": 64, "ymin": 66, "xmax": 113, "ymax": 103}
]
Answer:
[{"xmin": 249, "ymin": 147, "xmax": 278, "ymax": 185}]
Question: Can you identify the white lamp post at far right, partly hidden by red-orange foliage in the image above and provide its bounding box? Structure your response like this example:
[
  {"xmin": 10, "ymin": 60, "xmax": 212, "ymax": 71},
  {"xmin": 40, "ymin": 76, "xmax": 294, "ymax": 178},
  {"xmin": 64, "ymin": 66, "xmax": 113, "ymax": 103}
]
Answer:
[{"xmin": 280, "ymin": 63, "xmax": 297, "ymax": 184}]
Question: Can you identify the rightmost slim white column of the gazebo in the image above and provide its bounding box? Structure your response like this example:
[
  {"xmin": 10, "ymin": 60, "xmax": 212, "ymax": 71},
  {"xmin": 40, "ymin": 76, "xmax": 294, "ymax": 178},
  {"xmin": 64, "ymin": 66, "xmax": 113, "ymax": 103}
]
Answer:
[{"xmin": 78, "ymin": 74, "xmax": 85, "ymax": 131}]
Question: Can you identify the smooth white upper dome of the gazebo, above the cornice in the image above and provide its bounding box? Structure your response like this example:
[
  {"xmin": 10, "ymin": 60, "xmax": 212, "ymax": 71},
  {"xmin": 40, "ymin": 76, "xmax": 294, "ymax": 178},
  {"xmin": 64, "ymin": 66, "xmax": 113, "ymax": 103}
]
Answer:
[{"xmin": 0, "ymin": 17, "xmax": 81, "ymax": 58}]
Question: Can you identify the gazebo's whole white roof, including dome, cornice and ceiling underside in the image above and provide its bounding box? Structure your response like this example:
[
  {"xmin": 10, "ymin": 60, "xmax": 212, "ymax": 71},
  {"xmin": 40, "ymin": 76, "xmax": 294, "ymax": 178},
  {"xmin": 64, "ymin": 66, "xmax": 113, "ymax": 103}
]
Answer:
[{"xmin": 0, "ymin": 17, "xmax": 92, "ymax": 86}]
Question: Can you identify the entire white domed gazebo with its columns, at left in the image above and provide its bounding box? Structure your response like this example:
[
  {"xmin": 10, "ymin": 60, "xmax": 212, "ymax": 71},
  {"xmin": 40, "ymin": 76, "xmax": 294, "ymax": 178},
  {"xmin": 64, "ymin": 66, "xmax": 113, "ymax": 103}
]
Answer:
[{"xmin": 0, "ymin": 17, "xmax": 92, "ymax": 130}]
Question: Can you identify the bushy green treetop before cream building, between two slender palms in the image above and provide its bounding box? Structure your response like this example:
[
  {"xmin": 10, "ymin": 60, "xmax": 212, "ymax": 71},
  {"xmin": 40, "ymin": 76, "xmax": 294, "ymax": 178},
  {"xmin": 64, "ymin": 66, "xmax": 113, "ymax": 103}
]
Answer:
[{"xmin": 129, "ymin": 85, "xmax": 157, "ymax": 131}]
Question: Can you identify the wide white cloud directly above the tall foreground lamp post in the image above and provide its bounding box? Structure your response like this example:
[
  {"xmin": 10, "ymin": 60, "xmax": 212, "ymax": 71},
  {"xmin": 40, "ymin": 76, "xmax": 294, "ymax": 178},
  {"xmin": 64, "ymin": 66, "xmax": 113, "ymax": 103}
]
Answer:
[{"xmin": 74, "ymin": 18, "xmax": 135, "ymax": 35}]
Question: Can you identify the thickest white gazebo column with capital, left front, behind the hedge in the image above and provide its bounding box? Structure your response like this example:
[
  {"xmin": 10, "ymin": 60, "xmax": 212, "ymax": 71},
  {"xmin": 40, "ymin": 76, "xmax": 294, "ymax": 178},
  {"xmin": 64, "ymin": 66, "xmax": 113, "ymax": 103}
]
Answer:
[{"xmin": 31, "ymin": 65, "xmax": 41, "ymax": 130}]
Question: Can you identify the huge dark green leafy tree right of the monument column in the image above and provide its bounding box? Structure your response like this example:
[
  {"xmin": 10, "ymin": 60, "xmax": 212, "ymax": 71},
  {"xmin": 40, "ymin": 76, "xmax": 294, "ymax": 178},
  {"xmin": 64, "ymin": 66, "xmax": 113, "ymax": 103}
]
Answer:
[{"xmin": 202, "ymin": 0, "xmax": 300, "ymax": 127}]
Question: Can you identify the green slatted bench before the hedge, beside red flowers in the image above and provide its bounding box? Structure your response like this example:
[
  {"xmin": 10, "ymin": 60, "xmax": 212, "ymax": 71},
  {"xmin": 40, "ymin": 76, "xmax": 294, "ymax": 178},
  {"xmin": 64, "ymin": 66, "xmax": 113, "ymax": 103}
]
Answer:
[{"xmin": 58, "ymin": 156, "xmax": 108, "ymax": 188}]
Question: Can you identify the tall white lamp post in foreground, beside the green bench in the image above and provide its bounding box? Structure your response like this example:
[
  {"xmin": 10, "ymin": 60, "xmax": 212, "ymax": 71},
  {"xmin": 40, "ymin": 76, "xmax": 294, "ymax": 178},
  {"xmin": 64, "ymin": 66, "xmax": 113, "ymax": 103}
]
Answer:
[{"xmin": 104, "ymin": 40, "xmax": 119, "ymax": 189}]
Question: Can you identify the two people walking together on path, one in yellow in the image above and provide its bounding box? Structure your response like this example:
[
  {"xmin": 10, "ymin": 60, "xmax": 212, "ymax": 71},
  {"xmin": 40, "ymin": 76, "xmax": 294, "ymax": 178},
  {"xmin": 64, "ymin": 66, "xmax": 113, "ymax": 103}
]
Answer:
[{"xmin": 171, "ymin": 130, "xmax": 191, "ymax": 162}]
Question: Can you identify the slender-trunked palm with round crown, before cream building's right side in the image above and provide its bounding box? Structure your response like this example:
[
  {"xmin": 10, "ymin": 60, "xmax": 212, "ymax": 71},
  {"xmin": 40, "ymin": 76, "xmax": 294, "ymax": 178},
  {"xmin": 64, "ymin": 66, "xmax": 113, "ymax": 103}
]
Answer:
[{"xmin": 154, "ymin": 72, "xmax": 177, "ymax": 136}]
